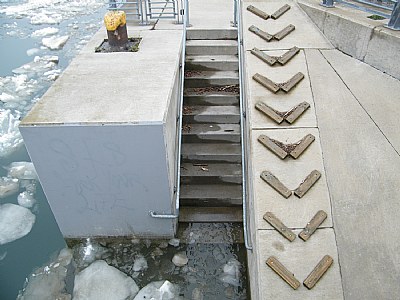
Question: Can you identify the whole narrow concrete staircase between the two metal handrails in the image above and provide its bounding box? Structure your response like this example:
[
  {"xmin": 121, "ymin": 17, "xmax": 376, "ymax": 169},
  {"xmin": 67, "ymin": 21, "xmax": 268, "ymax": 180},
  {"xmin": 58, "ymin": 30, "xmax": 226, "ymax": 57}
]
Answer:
[{"xmin": 179, "ymin": 30, "xmax": 242, "ymax": 222}]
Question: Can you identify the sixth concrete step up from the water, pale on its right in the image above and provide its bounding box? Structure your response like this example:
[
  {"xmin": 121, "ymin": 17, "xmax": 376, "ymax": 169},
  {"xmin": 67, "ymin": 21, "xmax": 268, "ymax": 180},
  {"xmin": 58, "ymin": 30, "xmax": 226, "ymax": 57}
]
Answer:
[{"xmin": 183, "ymin": 106, "xmax": 240, "ymax": 124}]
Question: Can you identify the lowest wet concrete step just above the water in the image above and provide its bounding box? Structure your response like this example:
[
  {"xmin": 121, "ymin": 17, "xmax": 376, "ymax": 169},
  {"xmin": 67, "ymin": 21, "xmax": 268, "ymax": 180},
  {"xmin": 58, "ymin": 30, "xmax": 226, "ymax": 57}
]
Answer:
[{"xmin": 179, "ymin": 206, "xmax": 243, "ymax": 223}]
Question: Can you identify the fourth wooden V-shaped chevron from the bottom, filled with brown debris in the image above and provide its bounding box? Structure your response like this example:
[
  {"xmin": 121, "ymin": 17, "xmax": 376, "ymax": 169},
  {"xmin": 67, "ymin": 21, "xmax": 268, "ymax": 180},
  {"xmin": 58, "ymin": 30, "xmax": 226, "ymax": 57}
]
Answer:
[{"xmin": 258, "ymin": 134, "xmax": 315, "ymax": 159}]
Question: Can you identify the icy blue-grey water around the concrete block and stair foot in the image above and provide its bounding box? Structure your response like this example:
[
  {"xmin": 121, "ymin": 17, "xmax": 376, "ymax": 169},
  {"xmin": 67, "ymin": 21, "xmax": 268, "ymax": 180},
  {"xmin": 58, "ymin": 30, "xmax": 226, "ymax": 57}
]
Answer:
[{"xmin": 0, "ymin": 0, "xmax": 247, "ymax": 300}]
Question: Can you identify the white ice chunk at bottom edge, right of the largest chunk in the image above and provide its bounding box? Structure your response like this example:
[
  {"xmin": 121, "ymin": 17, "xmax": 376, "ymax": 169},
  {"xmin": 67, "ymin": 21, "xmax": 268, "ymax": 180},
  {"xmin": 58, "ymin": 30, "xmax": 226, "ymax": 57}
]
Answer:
[{"xmin": 133, "ymin": 280, "xmax": 182, "ymax": 300}]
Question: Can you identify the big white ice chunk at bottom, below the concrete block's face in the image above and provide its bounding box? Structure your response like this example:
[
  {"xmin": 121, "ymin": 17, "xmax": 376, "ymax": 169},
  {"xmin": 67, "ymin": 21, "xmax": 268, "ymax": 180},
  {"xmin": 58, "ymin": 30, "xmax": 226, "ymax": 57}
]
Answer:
[{"xmin": 73, "ymin": 260, "xmax": 139, "ymax": 300}]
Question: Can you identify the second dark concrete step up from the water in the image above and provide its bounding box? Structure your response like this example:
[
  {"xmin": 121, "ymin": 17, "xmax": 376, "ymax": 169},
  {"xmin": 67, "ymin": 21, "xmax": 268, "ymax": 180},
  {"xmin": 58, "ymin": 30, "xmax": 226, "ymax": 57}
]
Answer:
[{"xmin": 180, "ymin": 184, "xmax": 242, "ymax": 200}]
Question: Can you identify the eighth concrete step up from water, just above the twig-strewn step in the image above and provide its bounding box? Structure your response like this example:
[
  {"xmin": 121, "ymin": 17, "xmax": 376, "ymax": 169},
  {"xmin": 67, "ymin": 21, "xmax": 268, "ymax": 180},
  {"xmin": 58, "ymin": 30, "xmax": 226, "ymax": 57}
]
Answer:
[{"xmin": 185, "ymin": 70, "xmax": 239, "ymax": 88}]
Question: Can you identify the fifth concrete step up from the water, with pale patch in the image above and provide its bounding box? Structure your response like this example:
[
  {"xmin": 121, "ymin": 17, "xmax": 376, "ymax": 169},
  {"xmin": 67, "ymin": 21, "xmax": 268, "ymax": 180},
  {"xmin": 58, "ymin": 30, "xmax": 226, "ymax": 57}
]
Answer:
[{"xmin": 182, "ymin": 124, "xmax": 240, "ymax": 143}]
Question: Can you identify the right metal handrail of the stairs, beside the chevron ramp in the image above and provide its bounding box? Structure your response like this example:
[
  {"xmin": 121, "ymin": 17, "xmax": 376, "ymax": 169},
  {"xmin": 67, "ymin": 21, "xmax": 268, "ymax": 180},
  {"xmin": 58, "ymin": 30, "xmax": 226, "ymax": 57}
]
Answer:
[{"xmin": 238, "ymin": 0, "xmax": 253, "ymax": 250}]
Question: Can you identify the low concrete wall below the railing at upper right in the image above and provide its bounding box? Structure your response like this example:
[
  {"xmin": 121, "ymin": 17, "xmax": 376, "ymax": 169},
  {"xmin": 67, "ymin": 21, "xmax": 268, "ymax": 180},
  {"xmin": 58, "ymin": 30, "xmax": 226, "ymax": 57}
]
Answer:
[{"xmin": 298, "ymin": 0, "xmax": 400, "ymax": 79}]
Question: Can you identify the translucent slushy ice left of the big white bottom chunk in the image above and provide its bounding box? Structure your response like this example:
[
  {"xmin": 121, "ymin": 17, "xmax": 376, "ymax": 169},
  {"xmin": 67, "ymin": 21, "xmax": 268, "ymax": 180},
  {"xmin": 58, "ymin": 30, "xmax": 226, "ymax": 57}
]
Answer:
[{"xmin": 17, "ymin": 249, "xmax": 72, "ymax": 300}]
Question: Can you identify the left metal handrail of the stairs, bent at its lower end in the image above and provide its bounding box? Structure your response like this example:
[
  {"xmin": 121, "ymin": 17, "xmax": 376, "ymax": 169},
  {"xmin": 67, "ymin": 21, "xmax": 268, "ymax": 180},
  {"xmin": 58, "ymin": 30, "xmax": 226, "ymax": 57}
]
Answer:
[{"xmin": 149, "ymin": 0, "xmax": 189, "ymax": 219}]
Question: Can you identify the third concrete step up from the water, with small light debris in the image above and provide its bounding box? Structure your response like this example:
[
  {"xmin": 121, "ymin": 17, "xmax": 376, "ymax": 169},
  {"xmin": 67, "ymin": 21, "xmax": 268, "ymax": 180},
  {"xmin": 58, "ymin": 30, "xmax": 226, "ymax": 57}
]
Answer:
[{"xmin": 181, "ymin": 163, "xmax": 242, "ymax": 177}]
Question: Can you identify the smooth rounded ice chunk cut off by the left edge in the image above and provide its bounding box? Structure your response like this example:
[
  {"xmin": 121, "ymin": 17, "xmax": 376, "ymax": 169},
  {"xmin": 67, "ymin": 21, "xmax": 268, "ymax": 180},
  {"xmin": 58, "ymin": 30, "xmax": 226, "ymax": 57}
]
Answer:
[{"xmin": 0, "ymin": 203, "xmax": 36, "ymax": 245}]
